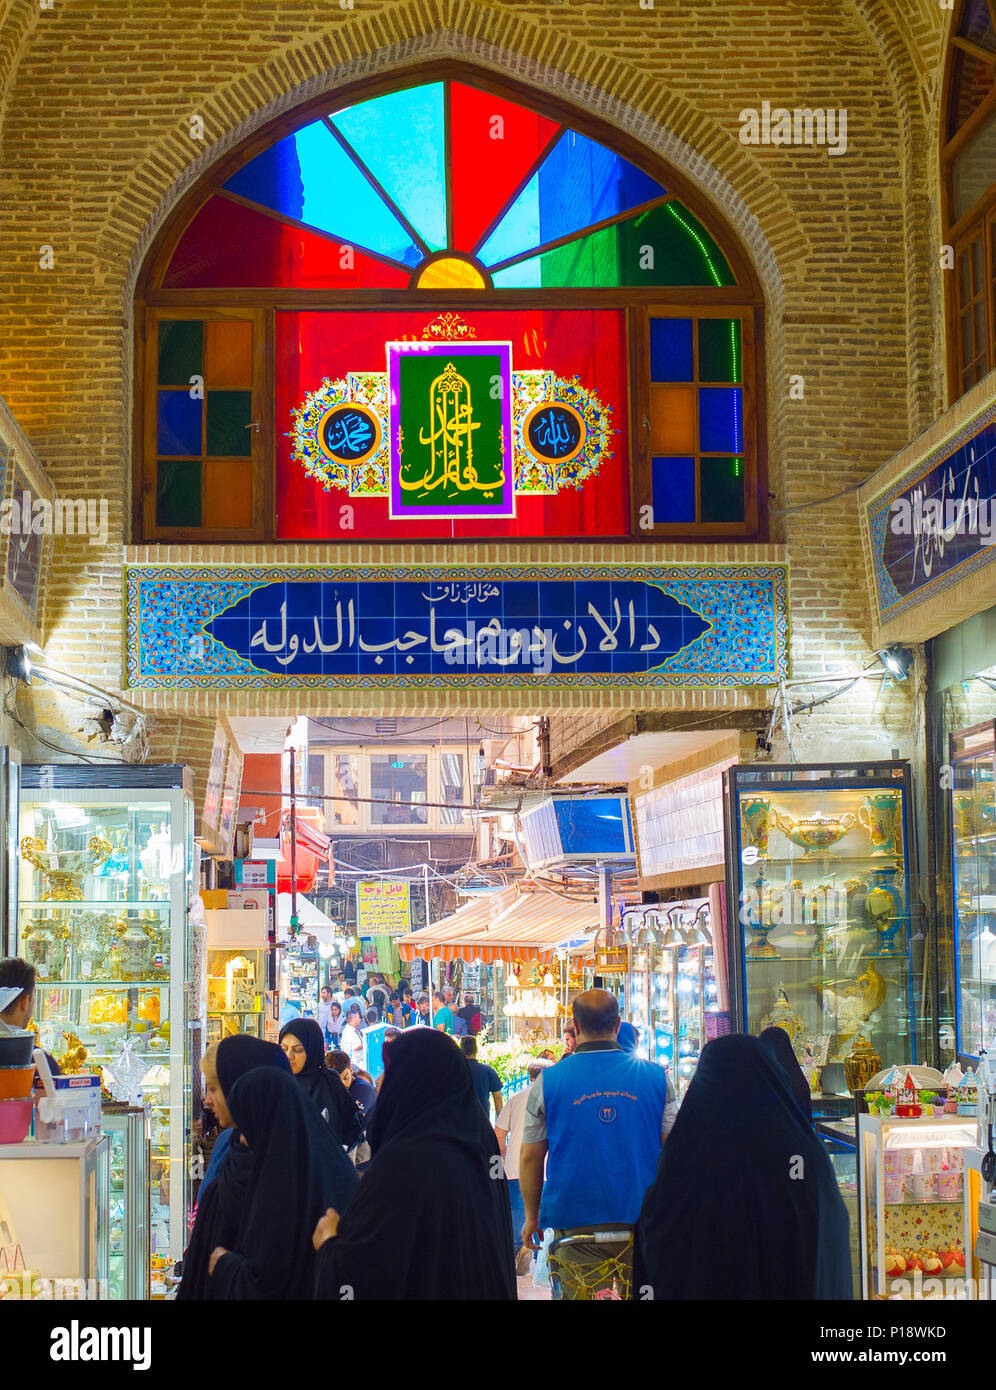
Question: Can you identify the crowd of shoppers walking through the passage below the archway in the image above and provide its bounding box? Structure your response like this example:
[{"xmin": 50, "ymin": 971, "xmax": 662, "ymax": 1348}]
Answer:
[{"xmin": 179, "ymin": 988, "xmax": 852, "ymax": 1300}]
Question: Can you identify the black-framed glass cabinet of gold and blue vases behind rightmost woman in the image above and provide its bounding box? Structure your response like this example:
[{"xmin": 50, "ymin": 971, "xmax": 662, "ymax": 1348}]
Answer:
[{"xmin": 724, "ymin": 762, "xmax": 925, "ymax": 1091}]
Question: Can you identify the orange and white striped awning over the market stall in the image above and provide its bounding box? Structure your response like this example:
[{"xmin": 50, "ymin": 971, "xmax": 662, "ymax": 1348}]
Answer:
[{"xmin": 397, "ymin": 888, "xmax": 599, "ymax": 965}]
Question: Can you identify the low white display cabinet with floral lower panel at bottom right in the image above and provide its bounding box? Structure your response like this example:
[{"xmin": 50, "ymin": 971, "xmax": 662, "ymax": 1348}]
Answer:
[{"xmin": 857, "ymin": 1115, "xmax": 979, "ymax": 1300}]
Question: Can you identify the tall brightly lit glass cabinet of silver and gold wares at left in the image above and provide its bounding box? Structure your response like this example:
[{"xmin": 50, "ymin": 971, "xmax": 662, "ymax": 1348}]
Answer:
[{"xmin": 14, "ymin": 763, "xmax": 195, "ymax": 1266}]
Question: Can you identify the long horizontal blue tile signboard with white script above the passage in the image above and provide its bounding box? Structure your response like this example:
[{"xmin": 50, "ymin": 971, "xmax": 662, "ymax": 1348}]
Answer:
[{"xmin": 125, "ymin": 564, "xmax": 788, "ymax": 689}]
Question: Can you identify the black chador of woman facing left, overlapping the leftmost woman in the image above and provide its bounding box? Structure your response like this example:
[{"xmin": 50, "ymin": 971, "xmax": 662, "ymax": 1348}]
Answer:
[{"xmin": 207, "ymin": 1068, "xmax": 357, "ymax": 1300}]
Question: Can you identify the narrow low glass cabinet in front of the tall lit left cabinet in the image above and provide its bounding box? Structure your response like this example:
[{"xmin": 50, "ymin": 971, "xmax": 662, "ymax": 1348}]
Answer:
[{"xmin": 101, "ymin": 1102, "xmax": 149, "ymax": 1298}]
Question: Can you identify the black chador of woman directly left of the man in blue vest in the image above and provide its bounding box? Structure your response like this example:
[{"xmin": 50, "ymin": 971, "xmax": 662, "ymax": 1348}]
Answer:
[{"xmin": 315, "ymin": 1029, "xmax": 515, "ymax": 1300}]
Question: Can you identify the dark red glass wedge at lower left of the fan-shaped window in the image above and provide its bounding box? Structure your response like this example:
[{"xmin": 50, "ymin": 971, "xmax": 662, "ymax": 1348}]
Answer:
[{"xmin": 163, "ymin": 196, "xmax": 411, "ymax": 289}]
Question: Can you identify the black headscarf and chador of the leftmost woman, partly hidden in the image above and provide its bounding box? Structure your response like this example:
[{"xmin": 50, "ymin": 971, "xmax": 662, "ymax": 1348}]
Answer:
[{"xmin": 176, "ymin": 1033, "xmax": 290, "ymax": 1300}]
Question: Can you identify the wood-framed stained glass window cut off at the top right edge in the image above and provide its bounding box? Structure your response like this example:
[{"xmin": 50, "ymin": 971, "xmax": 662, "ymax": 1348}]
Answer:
[{"xmin": 942, "ymin": 0, "xmax": 996, "ymax": 400}]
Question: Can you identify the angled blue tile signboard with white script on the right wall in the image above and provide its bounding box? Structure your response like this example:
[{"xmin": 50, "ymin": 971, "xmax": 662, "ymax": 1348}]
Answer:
[{"xmin": 865, "ymin": 404, "xmax": 996, "ymax": 623}]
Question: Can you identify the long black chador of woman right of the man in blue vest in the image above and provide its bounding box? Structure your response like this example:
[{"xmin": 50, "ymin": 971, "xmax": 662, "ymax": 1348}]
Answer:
[{"xmin": 633, "ymin": 1034, "xmax": 852, "ymax": 1300}]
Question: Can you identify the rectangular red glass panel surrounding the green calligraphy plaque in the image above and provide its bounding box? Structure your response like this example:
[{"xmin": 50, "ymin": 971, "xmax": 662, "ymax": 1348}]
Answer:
[{"xmin": 276, "ymin": 310, "xmax": 629, "ymax": 545}]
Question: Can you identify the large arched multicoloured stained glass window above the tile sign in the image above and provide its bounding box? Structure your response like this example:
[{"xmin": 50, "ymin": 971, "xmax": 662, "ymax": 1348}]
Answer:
[{"xmin": 136, "ymin": 75, "xmax": 764, "ymax": 542}]
